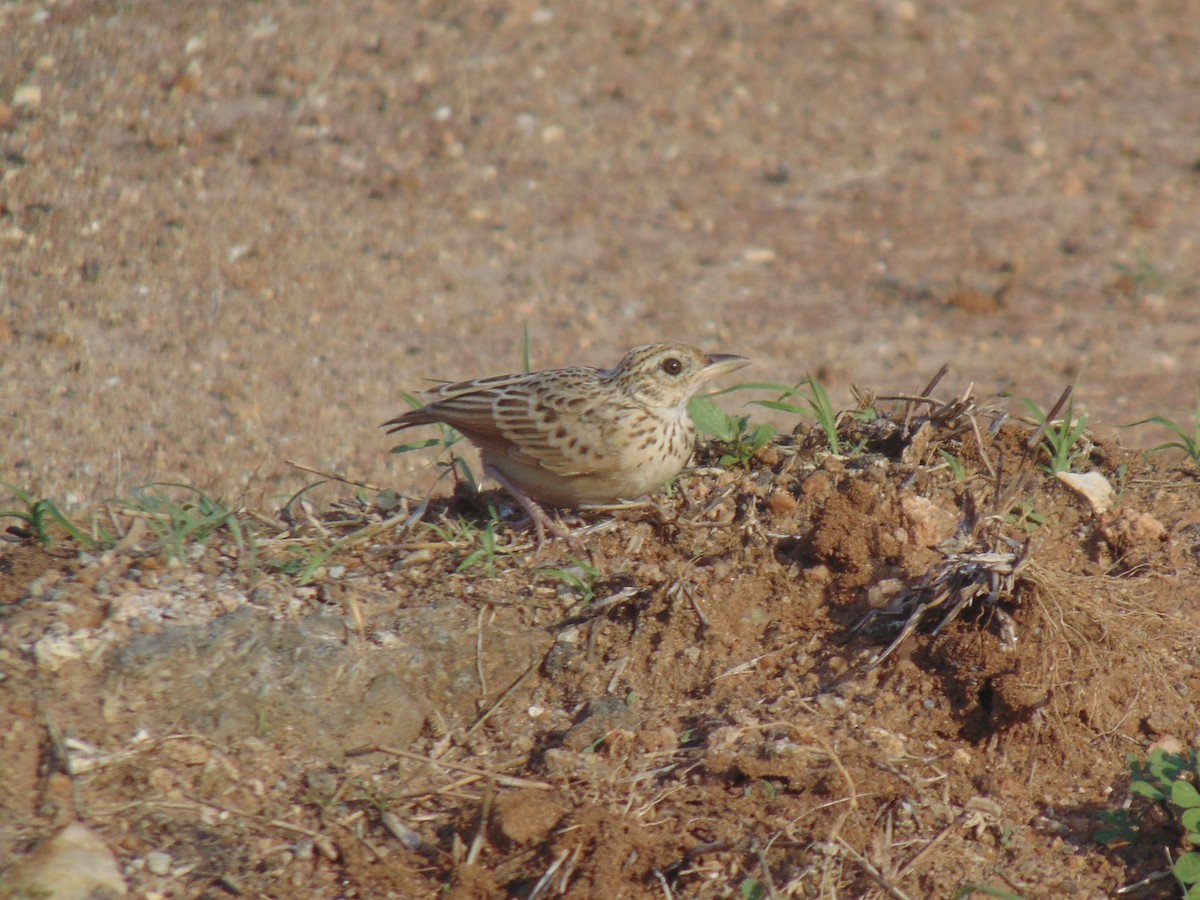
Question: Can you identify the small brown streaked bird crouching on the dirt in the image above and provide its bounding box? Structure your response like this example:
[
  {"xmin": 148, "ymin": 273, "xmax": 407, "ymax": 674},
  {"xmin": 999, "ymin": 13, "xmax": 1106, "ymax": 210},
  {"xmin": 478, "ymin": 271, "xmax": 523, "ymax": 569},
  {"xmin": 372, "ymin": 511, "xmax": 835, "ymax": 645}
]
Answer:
[{"xmin": 383, "ymin": 343, "xmax": 749, "ymax": 544}]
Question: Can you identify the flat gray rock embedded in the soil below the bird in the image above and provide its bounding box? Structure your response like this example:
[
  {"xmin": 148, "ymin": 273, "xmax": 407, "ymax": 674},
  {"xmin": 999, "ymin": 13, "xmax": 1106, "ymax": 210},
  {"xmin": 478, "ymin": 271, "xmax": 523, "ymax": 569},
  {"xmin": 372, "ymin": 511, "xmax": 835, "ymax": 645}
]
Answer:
[{"xmin": 104, "ymin": 601, "xmax": 550, "ymax": 754}]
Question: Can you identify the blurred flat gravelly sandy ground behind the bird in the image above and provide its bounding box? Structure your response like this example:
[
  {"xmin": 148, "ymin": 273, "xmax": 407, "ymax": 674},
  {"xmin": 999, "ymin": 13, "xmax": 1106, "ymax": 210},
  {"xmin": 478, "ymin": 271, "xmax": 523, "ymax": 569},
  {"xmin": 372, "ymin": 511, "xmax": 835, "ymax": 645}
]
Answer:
[{"xmin": 0, "ymin": 0, "xmax": 1200, "ymax": 505}]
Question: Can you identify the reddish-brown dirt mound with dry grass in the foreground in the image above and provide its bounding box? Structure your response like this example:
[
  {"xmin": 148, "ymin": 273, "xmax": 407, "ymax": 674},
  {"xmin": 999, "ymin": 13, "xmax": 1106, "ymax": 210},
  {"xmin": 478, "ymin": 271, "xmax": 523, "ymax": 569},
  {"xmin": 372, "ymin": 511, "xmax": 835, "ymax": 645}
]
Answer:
[{"xmin": 0, "ymin": 391, "xmax": 1200, "ymax": 898}]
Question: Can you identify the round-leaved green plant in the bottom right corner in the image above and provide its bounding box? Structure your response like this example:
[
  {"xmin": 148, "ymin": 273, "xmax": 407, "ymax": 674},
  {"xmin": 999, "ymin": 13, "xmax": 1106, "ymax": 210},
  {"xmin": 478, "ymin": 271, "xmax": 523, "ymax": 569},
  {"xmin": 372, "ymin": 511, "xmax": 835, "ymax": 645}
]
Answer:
[{"xmin": 1096, "ymin": 748, "xmax": 1200, "ymax": 900}]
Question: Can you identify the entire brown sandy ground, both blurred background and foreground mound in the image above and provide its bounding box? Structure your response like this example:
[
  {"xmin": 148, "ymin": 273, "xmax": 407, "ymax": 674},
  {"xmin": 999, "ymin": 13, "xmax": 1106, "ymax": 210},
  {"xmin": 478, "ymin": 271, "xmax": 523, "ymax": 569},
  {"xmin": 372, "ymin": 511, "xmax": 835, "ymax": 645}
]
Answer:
[{"xmin": 0, "ymin": 0, "xmax": 1200, "ymax": 900}]
